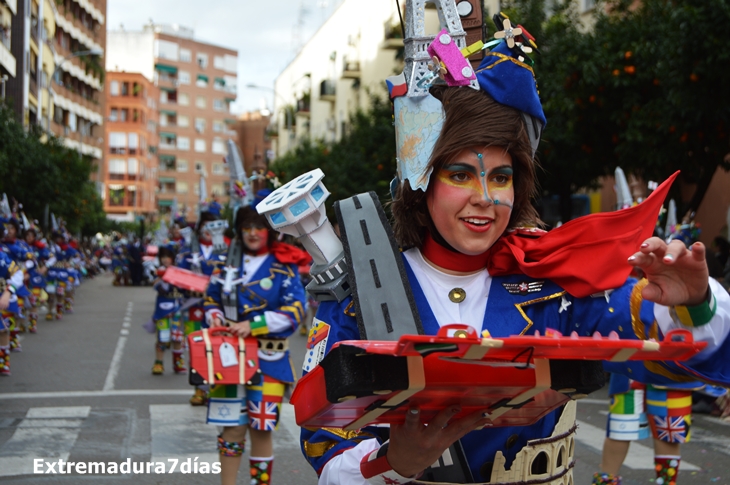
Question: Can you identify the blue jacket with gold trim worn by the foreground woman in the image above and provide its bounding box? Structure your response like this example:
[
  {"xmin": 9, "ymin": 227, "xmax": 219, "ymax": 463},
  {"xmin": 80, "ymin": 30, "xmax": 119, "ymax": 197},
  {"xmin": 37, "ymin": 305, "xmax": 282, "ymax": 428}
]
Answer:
[{"xmin": 301, "ymin": 253, "xmax": 730, "ymax": 483}]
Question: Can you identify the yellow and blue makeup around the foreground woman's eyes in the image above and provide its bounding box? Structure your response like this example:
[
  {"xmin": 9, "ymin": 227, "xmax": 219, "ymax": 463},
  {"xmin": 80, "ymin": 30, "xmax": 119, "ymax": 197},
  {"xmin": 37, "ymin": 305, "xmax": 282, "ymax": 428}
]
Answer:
[{"xmin": 437, "ymin": 152, "xmax": 514, "ymax": 209}]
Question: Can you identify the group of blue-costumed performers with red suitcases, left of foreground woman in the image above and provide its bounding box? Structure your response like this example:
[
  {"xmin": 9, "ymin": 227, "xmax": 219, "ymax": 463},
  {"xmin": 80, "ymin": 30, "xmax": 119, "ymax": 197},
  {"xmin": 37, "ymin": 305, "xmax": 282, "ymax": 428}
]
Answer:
[{"xmin": 141, "ymin": 189, "xmax": 311, "ymax": 484}]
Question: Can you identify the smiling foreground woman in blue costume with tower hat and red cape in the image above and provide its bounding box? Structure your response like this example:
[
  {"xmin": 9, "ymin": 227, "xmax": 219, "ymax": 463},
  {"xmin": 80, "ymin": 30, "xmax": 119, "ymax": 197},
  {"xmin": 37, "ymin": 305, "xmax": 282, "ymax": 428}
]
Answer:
[{"xmin": 284, "ymin": 4, "xmax": 730, "ymax": 485}]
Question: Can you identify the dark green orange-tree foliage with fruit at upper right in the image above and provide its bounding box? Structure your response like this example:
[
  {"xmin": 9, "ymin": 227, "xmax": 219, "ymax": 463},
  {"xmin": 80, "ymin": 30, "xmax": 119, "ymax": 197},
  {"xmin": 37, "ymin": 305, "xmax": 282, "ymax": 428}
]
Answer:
[{"xmin": 504, "ymin": 0, "xmax": 730, "ymax": 220}]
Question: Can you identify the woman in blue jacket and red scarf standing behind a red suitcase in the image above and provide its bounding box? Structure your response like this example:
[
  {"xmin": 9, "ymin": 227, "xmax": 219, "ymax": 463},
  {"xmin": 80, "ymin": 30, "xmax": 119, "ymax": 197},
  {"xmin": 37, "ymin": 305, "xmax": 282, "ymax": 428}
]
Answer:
[{"xmin": 205, "ymin": 207, "xmax": 309, "ymax": 485}]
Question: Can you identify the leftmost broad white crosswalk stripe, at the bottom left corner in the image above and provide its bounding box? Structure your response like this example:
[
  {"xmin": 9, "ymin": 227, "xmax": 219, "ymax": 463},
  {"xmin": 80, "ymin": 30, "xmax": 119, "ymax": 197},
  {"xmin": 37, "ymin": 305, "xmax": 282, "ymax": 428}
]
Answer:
[{"xmin": 0, "ymin": 406, "xmax": 90, "ymax": 477}]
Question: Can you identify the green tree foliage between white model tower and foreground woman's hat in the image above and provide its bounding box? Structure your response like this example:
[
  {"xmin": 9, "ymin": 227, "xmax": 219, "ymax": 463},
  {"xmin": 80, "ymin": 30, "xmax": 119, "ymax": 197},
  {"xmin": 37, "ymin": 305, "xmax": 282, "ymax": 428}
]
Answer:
[{"xmin": 271, "ymin": 96, "xmax": 396, "ymax": 214}]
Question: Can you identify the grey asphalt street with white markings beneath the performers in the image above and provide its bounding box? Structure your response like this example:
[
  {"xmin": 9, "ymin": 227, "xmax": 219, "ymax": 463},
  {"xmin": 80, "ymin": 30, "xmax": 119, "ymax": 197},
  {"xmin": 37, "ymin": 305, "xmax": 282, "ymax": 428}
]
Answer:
[{"xmin": 0, "ymin": 275, "xmax": 730, "ymax": 485}]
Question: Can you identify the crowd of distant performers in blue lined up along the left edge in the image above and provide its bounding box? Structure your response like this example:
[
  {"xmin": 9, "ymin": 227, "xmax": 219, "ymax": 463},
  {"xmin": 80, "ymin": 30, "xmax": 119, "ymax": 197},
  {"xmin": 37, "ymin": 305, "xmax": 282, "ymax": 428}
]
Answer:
[{"xmin": 0, "ymin": 195, "xmax": 96, "ymax": 376}]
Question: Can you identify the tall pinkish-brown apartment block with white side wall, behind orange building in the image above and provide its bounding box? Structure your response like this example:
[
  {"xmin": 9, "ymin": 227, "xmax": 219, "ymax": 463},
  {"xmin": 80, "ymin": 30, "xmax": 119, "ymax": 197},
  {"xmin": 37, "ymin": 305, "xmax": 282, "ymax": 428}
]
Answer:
[{"xmin": 107, "ymin": 24, "xmax": 238, "ymax": 221}]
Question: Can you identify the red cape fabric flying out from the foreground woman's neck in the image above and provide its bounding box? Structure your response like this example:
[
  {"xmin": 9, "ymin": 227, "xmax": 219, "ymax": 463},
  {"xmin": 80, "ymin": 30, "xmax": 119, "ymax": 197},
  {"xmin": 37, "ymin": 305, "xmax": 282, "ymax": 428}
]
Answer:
[{"xmin": 487, "ymin": 172, "xmax": 679, "ymax": 298}]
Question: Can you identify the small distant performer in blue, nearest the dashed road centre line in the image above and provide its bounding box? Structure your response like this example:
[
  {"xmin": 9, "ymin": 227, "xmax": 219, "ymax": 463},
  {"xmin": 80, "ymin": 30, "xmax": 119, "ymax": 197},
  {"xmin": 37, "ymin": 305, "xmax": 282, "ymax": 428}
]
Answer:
[{"xmin": 152, "ymin": 245, "xmax": 187, "ymax": 375}]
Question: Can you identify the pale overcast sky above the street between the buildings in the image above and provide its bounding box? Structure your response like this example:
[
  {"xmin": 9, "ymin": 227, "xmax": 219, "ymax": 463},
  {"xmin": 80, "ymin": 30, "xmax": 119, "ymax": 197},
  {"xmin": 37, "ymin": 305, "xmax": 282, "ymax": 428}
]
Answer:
[{"xmin": 106, "ymin": 0, "xmax": 346, "ymax": 112}]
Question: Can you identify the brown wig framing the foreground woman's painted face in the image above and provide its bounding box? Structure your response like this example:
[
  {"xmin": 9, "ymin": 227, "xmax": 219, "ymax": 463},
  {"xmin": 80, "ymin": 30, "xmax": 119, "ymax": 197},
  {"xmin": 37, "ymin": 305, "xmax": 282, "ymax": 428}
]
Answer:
[{"xmin": 391, "ymin": 86, "xmax": 539, "ymax": 247}]
